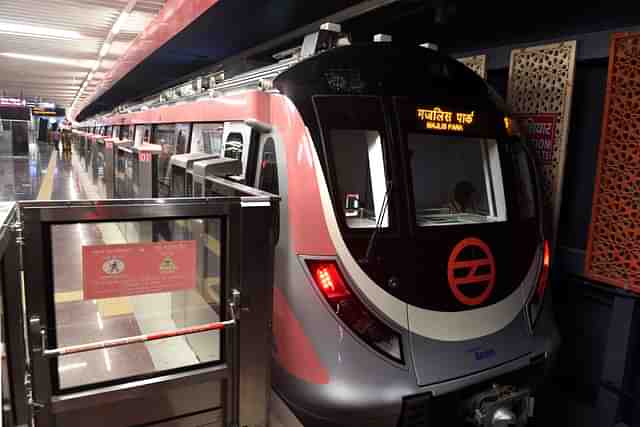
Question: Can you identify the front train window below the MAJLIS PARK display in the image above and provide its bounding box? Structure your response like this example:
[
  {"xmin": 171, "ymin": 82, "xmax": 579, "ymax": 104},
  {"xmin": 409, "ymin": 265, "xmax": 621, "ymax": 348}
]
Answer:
[{"xmin": 407, "ymin": 132, "xmax": 504, "ymax": 226}]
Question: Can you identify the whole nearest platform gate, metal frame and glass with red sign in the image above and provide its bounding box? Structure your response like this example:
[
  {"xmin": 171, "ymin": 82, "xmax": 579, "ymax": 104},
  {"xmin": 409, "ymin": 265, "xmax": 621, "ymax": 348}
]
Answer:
[{"xmin": 0, "ymin": 191, "xmax": 278, "ymax": 427}]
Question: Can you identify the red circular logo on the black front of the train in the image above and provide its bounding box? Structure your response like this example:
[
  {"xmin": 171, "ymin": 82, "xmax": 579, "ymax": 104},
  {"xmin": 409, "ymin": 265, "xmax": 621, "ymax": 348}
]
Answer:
[{"xmin": 447, "ymin": 237, "xmax": 496, "ymax": 306}]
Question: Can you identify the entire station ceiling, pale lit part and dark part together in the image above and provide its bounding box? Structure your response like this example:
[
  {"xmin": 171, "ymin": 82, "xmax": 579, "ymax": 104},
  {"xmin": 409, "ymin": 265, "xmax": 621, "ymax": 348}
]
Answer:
[{"xmin": 0, "ymin": 0, "xmax": 640, "ymax": 118}]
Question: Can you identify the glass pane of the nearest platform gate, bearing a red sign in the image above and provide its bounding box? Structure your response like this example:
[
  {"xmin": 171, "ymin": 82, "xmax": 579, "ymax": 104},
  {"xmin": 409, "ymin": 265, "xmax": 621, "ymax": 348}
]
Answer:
[{"xmin": 49, "ymin": 219, "xmax": 223, "ymax": 389}]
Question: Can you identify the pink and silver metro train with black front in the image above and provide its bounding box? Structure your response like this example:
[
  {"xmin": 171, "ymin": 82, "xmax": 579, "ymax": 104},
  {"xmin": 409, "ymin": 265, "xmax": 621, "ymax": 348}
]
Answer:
[{"xmin": 81, "ymin": 32, "xmax": 559, "ymax": 426}]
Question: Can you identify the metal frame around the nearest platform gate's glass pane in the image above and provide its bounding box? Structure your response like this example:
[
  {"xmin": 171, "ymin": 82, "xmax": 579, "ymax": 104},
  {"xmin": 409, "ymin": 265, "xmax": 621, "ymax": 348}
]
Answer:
[{"xmin": 20, "ymin": 198, "xmax": 278, "ymax": 427}]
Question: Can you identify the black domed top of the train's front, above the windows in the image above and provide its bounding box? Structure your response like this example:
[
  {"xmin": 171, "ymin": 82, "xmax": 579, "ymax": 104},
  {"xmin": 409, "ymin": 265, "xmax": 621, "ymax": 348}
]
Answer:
[{"xmin": 274, "ymin": 43, "xmax": 503, "ymax": 110}]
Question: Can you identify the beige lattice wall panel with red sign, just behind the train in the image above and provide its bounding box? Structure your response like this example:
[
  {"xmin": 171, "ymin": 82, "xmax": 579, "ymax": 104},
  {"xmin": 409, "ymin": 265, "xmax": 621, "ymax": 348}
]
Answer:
[{"xmin": 507, "ymin": 41, "xmax": 576, "ymax": 242}]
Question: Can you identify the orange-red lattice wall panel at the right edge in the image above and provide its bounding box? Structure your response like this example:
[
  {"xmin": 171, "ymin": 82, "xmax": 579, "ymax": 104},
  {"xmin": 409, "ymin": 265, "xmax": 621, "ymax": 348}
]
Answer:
[{"xmin": 585, "ymin": 33, "xmax": 640, "ymax": 293}]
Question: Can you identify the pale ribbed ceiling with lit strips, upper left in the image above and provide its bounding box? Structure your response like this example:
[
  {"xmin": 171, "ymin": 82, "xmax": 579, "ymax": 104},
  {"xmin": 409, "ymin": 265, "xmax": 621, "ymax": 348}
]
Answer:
[{"xmin": 0, "ymin": 0, "xmax": 165, "ymax": 107}]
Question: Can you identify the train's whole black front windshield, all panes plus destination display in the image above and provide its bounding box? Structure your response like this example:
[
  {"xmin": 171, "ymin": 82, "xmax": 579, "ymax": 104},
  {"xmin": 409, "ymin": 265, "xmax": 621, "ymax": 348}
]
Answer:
[{"xmin": 313, "ymin": 96, "xmax": 536, "ymax": 234}]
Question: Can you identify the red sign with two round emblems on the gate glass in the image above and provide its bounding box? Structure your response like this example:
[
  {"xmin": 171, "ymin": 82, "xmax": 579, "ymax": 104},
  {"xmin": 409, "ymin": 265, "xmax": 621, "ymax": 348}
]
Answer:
[{"xmin": 82, "ymin": 240, "xmax": 196, "ymax": 299}]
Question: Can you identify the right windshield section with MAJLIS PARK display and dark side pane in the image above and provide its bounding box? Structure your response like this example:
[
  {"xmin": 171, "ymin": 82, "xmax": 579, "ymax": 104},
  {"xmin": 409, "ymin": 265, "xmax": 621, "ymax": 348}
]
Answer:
[{"xmin": 393, "ymin": 97, "xmax": 539, "ymax": 229}]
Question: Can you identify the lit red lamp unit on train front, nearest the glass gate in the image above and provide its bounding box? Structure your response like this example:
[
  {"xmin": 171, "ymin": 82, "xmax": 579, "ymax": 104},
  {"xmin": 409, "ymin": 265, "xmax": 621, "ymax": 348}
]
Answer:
[{"xmin": 306, "ymin": 259, "xmax": 404, "ymax": 363}]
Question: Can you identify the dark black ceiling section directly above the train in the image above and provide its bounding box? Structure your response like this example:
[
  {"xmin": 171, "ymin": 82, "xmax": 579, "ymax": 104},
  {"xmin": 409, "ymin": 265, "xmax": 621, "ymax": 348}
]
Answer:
[{"xmin": 79, "ymin": 0, "xmax": 640, "ymax": 118}]
